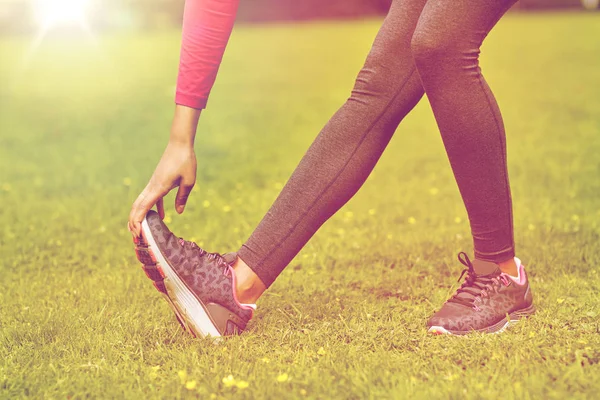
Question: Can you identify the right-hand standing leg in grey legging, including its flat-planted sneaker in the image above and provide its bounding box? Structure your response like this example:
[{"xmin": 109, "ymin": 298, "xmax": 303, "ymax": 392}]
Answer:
[{"xmin": 412, "ymin": 0, "xmax": 535, "ymax": 334}]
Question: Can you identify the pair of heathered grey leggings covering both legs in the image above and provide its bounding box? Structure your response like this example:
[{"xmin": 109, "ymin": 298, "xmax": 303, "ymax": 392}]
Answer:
[{"xmin": 238, "ymin": 0, "xmax": 515, "ymax": 286}]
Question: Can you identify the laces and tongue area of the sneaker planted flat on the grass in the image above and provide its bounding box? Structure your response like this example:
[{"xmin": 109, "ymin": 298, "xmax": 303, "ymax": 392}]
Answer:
[{"xmin": 448, "ymin": 252, "xmax": 508, "ymax": 310}]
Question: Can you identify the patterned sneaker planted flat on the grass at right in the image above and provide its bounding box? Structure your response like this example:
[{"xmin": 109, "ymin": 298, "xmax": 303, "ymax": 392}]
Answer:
[{"xmin": 427, "ymin": 253, "xmax": 535, "ymax": 335}]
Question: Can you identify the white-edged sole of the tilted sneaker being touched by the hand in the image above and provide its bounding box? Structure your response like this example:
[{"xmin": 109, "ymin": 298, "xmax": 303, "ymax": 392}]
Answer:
[{"xmin": 134, "ymin": 218, "xmax": 221, "ymax": 338}]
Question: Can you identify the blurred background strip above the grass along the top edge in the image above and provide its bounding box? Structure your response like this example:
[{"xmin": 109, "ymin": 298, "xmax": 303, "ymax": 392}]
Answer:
[{"xmin": 0, "ymin": 0, "xmax": 600, "ymax": 33}]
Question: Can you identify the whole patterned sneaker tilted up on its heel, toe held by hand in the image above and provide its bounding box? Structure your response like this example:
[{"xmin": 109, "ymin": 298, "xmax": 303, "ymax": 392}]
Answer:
[{"xmin": 134, "ymin": 211, "xmax": 256, "ymax": 337}]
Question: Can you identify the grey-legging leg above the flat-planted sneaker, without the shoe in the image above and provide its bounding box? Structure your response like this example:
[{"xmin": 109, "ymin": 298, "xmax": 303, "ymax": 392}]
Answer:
[{"xmin": 412, "ymin": 0, "xmax": 516, "ymax": 272}]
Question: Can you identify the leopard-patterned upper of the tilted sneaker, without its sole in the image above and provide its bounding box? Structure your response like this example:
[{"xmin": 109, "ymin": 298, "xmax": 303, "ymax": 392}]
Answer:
[{"xmin": 146, "ymin": 211, "xmax": 254, "ymax": 335}]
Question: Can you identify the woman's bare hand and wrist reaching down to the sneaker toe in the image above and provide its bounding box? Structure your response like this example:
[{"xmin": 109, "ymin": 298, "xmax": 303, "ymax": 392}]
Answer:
[{"xmin": 128, "ymin": 106, "xmax": 200, "ymax": 237}]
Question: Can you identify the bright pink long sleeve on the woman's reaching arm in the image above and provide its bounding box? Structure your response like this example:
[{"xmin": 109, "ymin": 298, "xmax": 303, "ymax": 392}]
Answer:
[{"xmin": 175, "ymin": 0, "xmax": 239, "ymax": 109}]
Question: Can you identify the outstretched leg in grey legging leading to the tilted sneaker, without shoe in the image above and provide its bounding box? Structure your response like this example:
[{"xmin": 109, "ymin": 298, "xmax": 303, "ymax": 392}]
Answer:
[{"xmin": 236, "ymin": 0, "xmax": 425, "ymax": 290}]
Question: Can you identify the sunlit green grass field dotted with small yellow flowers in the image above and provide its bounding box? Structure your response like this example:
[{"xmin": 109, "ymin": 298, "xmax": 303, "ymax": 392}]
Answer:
[{"xmin": 0, "ymin": 10, "xmax": 600, "ymax": 399}]
